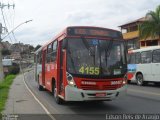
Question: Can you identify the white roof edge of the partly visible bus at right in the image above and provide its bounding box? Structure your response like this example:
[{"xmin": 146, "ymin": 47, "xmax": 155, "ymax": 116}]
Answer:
[{"xmin": 128, "ymin": 46, "xmax": 160, "ymax": 53}]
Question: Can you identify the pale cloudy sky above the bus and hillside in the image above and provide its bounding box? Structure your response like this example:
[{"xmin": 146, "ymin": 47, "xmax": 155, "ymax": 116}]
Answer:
[{"xmin": 0, "ymin": 0, "xmax": 160, "ymax": 46}]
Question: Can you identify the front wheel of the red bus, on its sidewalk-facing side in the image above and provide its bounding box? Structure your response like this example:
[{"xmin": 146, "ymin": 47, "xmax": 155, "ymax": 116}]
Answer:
[{"xmin": 52, "ymin": 83, "xmax": 64, "ymax": 105}]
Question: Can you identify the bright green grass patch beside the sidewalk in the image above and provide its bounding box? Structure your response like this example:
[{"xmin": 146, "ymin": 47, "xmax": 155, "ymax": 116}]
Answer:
[{"xmin": 0, "ymin": 75, "xmax": 16, "ymax": 113}]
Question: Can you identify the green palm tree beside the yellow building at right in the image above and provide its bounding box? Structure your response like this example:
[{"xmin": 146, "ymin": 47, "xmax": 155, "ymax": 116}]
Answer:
[{"xmin": 139, "ymin": 5, "xmax": 160, "ymax": 40}]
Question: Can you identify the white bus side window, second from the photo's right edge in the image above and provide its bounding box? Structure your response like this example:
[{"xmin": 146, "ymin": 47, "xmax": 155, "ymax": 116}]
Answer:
[{"xmin": 141, "ymin": 51, "xmax": 152, "ymax": 63}]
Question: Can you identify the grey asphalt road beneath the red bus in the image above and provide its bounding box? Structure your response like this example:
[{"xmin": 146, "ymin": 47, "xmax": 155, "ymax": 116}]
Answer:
[{"xmin": 25, "ymin": 71, "xmax": 160, "ymax": 120}]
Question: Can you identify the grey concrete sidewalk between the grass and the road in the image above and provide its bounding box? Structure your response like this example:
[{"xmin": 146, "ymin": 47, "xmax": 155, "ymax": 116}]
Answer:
[{"xmin": 2, "ymin": 75, "xmax": 46, "ymax": 114}]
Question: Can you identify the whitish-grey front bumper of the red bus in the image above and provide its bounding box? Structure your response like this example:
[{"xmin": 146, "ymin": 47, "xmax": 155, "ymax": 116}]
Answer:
[{"xmin": 65, "ymin": 85, "xmax": 127, "ymax": 101}]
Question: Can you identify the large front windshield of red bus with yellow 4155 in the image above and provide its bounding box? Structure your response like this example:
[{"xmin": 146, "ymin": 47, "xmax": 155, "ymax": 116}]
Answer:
[{"xmin": 66, "ymin": 38, "xmax": 126, "ymax": 76}]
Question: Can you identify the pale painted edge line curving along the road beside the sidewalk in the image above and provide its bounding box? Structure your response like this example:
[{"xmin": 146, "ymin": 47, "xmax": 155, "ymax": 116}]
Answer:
[{"xmin": 22, "ymin": 73, "xmax": 56, "ymax": 120}]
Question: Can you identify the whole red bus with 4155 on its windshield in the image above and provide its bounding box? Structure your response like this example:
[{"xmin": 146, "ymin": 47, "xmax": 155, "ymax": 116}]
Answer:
[{"xmin": 35, "ymin": 26, "xmax": 127, "ymax": 104}]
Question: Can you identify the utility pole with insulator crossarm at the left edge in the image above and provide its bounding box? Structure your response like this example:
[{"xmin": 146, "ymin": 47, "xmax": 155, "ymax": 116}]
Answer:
[{"xmin": 0, "ymin": 2, "xmax": 15, "ymax": 81}]
